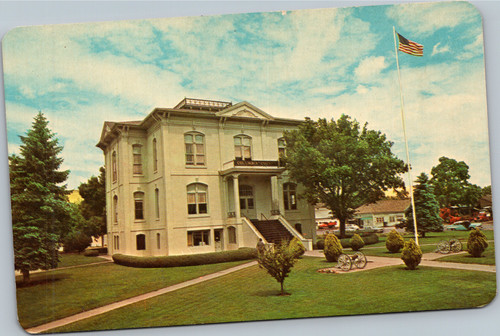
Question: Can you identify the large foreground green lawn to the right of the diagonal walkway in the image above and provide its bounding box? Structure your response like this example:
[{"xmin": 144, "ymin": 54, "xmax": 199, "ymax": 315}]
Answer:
[{"xmin": 47, "ymin": 257, "xmax": 496, "ymax": 332}]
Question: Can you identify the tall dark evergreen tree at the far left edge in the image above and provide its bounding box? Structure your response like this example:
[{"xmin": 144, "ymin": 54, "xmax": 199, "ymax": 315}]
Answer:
[{"xmin": 9, "ymin": 112, "xmax": 70, "ymax": 281}]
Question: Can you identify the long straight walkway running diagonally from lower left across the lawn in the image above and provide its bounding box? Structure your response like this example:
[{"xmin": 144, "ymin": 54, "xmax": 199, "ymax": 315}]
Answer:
[{"xmin": 26, "ymin": 261, "xmax": 257, "ymax": 334}]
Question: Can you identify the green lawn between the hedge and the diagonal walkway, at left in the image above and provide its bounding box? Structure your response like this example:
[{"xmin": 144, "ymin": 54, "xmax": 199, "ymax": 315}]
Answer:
[{"xmin": 17, "ymin": 257, "xmax": 248, "ymax": 328}]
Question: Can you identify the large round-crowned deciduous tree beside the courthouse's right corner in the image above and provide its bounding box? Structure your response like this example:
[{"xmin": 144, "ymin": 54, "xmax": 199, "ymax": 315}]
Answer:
[{"xmin": 284, "ymin": 115, "xmax": 406, "ymax": 237}]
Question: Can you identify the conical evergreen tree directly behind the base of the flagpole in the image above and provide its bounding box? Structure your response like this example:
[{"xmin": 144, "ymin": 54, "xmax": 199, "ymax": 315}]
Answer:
[{"xmin": 406, "ymin": 173, "xmax": 443, "ymax": 237}]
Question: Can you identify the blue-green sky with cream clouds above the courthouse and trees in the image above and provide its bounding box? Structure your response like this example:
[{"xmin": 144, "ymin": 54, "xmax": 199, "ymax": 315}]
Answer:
[{"xmin": 3, "ymin": 2, "xmax": 491, "ymax": 188}]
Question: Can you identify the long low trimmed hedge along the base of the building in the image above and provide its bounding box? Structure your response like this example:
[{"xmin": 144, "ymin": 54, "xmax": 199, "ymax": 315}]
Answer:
[{"xmin": 113, "ymin": 247, "xmax": 257, "ymax": 268}]
